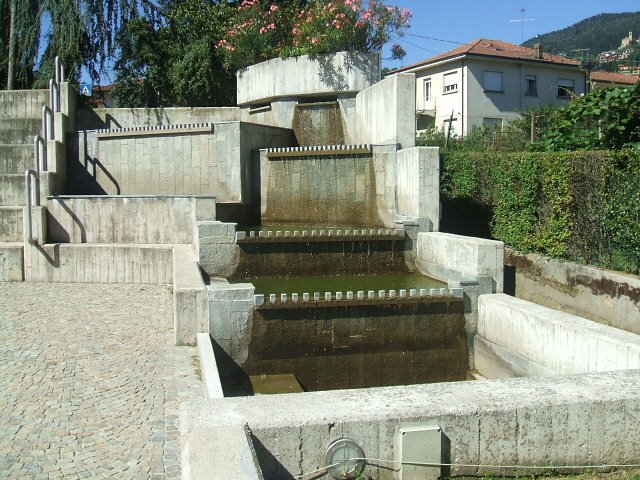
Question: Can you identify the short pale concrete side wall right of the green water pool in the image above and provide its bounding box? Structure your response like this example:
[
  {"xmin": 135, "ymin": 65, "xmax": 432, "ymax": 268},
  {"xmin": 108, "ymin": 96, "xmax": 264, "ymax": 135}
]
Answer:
[{"xmin": 416, "ymin": 232, "xmax": 504, "ymax": 293}]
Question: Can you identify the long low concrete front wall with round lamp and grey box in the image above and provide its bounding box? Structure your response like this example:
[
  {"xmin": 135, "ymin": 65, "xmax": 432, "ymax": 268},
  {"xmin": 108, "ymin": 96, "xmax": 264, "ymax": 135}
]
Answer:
[{"xmin": 180, "ymin": 370, "xmax": 640, "ymax": 480}]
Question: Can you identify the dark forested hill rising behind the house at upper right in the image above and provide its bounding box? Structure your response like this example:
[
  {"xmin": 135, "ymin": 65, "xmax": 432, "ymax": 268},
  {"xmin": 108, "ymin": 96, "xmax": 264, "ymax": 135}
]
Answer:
[{"xmin": 523, "ymin": 12, "xmax": 640, "ymax": 56}]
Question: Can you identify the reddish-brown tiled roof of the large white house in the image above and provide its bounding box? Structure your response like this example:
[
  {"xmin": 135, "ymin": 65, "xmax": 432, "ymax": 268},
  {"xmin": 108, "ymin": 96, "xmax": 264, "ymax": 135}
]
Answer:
[{"xmin": 393, "ymin": 38, "xmax": 580, "ymax": 73}]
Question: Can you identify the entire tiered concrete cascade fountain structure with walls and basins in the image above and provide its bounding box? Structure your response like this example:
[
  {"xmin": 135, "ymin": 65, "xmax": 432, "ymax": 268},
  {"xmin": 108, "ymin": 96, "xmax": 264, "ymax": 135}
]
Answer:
[{"xmin": 0, "ymin": 53, "xmax": 640, "ymax": 479}]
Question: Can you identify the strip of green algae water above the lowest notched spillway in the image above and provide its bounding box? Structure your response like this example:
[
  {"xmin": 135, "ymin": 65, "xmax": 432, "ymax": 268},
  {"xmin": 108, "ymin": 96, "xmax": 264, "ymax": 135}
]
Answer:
[{"xmin": 229, "ymin": 273, "xmax": 447, "ymax": 295}]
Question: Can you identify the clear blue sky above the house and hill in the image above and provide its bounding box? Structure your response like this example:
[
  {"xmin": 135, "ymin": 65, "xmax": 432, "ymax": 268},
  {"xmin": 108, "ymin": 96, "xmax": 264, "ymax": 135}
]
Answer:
[{"xmin": 383, "ymin": 0, "xmax": 640, "ymax": 67}]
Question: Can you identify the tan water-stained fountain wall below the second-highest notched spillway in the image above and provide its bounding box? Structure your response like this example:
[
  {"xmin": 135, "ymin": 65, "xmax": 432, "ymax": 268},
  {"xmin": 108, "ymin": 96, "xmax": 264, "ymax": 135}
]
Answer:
[{"xmin": 260, "ymin": 145, "xmax": 396, "ymax": 228}]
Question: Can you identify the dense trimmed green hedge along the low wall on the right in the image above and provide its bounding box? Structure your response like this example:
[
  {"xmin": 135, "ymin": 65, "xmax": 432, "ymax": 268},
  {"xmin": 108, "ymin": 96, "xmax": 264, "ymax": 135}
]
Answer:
[{"xmin": 441, "ymin": 150, "xmax": 640, "ymax": 273}]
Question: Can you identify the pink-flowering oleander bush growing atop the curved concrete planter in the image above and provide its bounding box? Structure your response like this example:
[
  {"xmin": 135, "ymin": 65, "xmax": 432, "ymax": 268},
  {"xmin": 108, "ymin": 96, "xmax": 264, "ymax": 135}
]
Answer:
[{"xmin": 217, "ymin": 0, "xmax": 411, "ymax": 68}]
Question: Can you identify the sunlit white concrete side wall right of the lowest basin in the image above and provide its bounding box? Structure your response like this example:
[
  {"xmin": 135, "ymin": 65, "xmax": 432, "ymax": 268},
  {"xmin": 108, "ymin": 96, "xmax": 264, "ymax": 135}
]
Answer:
[{"xmin": 476, "ymin": 294, "xmax": 640, "ymax": 378}]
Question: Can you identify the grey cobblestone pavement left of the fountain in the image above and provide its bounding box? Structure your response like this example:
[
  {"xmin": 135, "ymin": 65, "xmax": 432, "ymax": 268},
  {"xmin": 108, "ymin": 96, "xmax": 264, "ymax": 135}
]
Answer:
[{"xmin": 0, "ymin": 283, "xmax": 202, "ymax": 479}]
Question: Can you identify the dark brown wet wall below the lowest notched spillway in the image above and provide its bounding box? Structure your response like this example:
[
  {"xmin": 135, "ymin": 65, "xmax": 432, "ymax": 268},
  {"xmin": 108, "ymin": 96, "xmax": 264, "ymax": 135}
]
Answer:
[{"xmin": 241, "ymin": 297, "xmax": 468, "ymax": 391}]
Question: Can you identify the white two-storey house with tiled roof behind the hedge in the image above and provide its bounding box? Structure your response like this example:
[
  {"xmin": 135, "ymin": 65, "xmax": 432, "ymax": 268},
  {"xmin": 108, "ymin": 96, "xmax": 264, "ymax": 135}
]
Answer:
[{"xmin": 393, "ymin": 39, "xmax": 586, "ymax": 135}]
